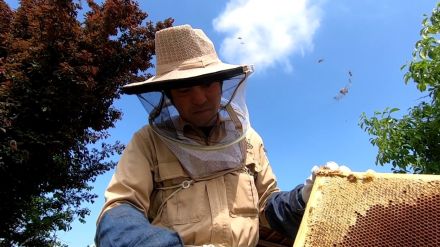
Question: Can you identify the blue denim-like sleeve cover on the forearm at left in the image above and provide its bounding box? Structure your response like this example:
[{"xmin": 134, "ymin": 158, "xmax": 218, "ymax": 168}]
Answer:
[{"xmin": 95, "ymin": 204, "xmax": 183, "ymax": 247}]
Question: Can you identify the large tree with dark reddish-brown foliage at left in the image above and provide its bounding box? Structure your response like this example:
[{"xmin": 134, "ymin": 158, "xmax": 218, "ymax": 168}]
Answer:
[{"xmin": 0, "ymin": 0, "xmax": 173, "ymax": 246}]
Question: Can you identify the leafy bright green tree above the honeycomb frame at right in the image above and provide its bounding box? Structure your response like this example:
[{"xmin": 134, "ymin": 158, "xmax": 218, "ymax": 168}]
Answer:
[{"xmin": 360, "ymin": 3, "xmax": 440, "ymax": 174}]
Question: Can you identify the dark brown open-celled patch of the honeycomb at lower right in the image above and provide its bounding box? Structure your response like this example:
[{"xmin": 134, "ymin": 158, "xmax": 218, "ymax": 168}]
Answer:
[{"xmin": 338, "ymin": 196, "xmax": 440, "ymax": 247}]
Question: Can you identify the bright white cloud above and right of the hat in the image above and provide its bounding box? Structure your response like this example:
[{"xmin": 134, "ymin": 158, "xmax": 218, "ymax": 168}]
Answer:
[{"xmin": 213, "ymin": 0, "xmax": 321, "ymax": 71}]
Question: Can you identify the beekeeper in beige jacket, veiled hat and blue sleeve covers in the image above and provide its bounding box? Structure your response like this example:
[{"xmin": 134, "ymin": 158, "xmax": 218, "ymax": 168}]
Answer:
[{"xmin": 95, "ymin": 25, "xmax": 348, "ymax": 247}]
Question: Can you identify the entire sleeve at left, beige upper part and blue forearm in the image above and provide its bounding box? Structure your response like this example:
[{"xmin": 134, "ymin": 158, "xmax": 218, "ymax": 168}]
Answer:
[{"xmin": 95, "ymin": 127, "xmax": 183, "ymax": 247}]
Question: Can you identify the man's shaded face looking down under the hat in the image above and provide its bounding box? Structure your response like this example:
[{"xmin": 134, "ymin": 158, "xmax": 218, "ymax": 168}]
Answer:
[{"xmin": 170, "ymin": 82, "xmax": 222, "ymax": 127}]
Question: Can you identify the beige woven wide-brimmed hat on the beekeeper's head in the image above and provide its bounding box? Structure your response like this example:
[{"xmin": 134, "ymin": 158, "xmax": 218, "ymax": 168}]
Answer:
[{"xmin": 123, "ymin": 25, "xmax": 252, "ymax": 94}]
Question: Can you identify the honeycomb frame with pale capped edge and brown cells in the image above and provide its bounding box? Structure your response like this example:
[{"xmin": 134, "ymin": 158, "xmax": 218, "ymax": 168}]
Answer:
[{"xmin": 293, "ymin": 170, "xmax": 440, "ymax": 247}]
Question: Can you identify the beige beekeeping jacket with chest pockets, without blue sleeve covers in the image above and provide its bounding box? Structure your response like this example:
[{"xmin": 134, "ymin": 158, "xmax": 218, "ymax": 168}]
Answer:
[{"xmin": 101, "ymin": 126, "xmax": 279, "ymax": 246}]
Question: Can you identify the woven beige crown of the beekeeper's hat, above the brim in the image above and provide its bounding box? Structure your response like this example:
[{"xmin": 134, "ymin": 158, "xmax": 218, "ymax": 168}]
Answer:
[{"xmin": 155, "ymin": 25, "xmax": 219, "ymax": 75}]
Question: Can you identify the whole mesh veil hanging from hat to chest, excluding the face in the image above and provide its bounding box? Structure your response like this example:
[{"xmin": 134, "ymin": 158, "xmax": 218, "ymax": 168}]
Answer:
[{"xmin": 138, "ymin": 68, "xmax": 250, "ymax": 180}]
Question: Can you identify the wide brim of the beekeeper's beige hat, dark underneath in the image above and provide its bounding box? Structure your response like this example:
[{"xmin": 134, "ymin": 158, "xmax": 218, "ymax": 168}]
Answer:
[{"xmin": 122, "ymin": 62, "xmax": 249, "ymax": 94}]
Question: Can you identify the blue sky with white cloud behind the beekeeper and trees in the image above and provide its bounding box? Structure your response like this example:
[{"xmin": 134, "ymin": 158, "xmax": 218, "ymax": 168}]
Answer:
[{"xmin": 6, "ymin": 0, "xmax": 436, "ymax": 247}]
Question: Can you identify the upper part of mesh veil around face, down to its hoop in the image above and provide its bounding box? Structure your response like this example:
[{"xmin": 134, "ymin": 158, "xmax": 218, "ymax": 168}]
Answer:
[{"xmin": 138, "ymin": 70, "xmax": 249, "ymax": 149}]
